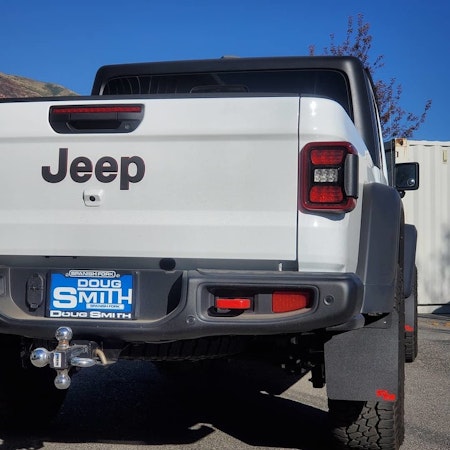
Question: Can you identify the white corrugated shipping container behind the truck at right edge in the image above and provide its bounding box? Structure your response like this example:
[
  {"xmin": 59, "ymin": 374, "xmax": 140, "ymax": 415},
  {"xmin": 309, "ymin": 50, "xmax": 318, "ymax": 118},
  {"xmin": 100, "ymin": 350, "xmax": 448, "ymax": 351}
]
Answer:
[{"xmin": 394, "ymin": 139, "xmax": 450, "ymax": 313}]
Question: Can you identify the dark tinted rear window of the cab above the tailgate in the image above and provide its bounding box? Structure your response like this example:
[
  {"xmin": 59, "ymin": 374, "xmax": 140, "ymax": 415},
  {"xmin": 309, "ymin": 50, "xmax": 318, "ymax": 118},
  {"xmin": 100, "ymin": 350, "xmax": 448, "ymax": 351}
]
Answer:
[{"xmin": 102, "ymin": 69, "xmax": 351, "ymax": 116}]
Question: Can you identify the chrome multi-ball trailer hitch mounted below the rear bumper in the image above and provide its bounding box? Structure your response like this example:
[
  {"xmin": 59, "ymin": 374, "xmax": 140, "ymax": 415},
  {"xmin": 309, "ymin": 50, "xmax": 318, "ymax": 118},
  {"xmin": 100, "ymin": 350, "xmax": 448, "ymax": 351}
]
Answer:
[{"xmin": 30, "ymin": 327, "xmax": 107, "ymax": 389}]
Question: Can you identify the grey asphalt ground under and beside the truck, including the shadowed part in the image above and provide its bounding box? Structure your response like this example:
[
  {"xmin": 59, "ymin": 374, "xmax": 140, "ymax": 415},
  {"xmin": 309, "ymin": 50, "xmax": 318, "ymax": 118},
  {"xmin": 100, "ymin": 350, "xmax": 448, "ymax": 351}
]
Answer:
[{"xmin": 0, "ymin": 315, "xmax": 450, "ymax": 450}]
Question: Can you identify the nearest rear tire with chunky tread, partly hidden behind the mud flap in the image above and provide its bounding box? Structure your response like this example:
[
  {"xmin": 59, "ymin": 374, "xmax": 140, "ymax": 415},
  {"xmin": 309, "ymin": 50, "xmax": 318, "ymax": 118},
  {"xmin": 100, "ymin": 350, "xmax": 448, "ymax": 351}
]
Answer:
[{"xmin": 328, "ymin": 269, "xmax": 405, "ymax": 450}]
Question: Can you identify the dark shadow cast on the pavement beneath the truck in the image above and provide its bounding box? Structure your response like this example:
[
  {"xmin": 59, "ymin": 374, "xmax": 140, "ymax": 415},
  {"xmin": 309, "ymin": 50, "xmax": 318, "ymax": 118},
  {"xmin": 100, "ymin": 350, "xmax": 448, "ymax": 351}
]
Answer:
[{"xmin": 0, "ymin": 361, "xmax": 329, "ymax": 450}]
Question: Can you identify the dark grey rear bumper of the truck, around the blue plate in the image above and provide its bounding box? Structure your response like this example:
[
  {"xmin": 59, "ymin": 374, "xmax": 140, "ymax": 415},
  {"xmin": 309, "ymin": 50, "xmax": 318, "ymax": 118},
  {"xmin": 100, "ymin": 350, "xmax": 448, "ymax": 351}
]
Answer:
[{"xmin": 0, "ymin": 268, "xmax": 364, "ymax": 342}]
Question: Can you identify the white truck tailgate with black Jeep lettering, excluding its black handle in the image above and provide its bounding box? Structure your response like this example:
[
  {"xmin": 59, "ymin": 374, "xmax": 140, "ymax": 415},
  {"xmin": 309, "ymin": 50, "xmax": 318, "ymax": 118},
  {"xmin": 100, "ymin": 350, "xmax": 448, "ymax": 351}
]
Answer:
[{"xmin": 0, "ymin": 96, "xmax": 299, "ymax": 262}]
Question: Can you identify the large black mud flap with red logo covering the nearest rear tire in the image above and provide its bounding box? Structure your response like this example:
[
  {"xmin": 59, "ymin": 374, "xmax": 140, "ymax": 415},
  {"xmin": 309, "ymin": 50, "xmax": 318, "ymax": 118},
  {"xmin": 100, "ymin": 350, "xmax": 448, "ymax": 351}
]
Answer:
[{"xmin": 325, "ymin": 310, "xmax": 403, "ymax": 401}]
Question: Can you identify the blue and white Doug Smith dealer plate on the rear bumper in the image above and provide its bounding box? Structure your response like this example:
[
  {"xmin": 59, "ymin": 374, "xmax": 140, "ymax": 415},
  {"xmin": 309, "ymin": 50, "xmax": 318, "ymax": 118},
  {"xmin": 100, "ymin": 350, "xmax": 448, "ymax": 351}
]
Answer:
[{"xmin": 47, "ymin": 270, "xmax": 134, "ymax": 320}]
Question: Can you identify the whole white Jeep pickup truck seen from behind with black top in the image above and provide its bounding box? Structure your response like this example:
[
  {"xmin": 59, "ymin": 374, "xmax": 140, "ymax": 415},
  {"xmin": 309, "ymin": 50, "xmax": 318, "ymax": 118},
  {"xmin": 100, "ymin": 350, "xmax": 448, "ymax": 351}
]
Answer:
[{"xmin": 0, "ymin": 57, "xmax": 418, "ymax": 449}]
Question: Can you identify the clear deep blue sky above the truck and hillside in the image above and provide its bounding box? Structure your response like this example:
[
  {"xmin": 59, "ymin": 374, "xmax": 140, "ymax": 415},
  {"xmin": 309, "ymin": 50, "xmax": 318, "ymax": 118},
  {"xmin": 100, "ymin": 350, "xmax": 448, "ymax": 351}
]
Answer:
[{"xmin": 0, "ymin": 0, "xmax": 450, "ymax": 141}]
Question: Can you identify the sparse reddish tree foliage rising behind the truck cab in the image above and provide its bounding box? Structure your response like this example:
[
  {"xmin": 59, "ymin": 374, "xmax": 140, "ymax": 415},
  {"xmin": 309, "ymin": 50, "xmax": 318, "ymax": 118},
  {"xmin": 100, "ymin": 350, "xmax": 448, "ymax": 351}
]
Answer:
[{"xmin": 309, "ymin": 14, "xmax": 431, "ymax": 138}]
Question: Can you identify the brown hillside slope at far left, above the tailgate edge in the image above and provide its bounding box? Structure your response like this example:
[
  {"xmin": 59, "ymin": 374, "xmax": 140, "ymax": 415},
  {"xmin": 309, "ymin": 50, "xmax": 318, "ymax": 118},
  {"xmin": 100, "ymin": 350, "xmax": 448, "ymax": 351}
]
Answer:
[{"xmin": 0, "ymin": 72, "xmax": 77, "ymax": 98}]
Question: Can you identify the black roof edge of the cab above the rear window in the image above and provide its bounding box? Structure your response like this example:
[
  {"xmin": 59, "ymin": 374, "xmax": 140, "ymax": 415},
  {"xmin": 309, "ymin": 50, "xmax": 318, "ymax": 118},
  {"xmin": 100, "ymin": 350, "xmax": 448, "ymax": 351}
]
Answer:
[{"xmin": 92, "ymin": 56, "xmax": 364, "ymax": 95}]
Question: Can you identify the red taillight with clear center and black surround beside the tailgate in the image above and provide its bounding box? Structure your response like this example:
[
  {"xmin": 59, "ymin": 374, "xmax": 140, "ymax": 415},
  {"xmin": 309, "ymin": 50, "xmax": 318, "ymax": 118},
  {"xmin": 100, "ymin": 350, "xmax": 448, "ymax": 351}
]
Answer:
[{"xmin": 299, "ymin": 142, "xmax": 358, "ymax": 213}]
